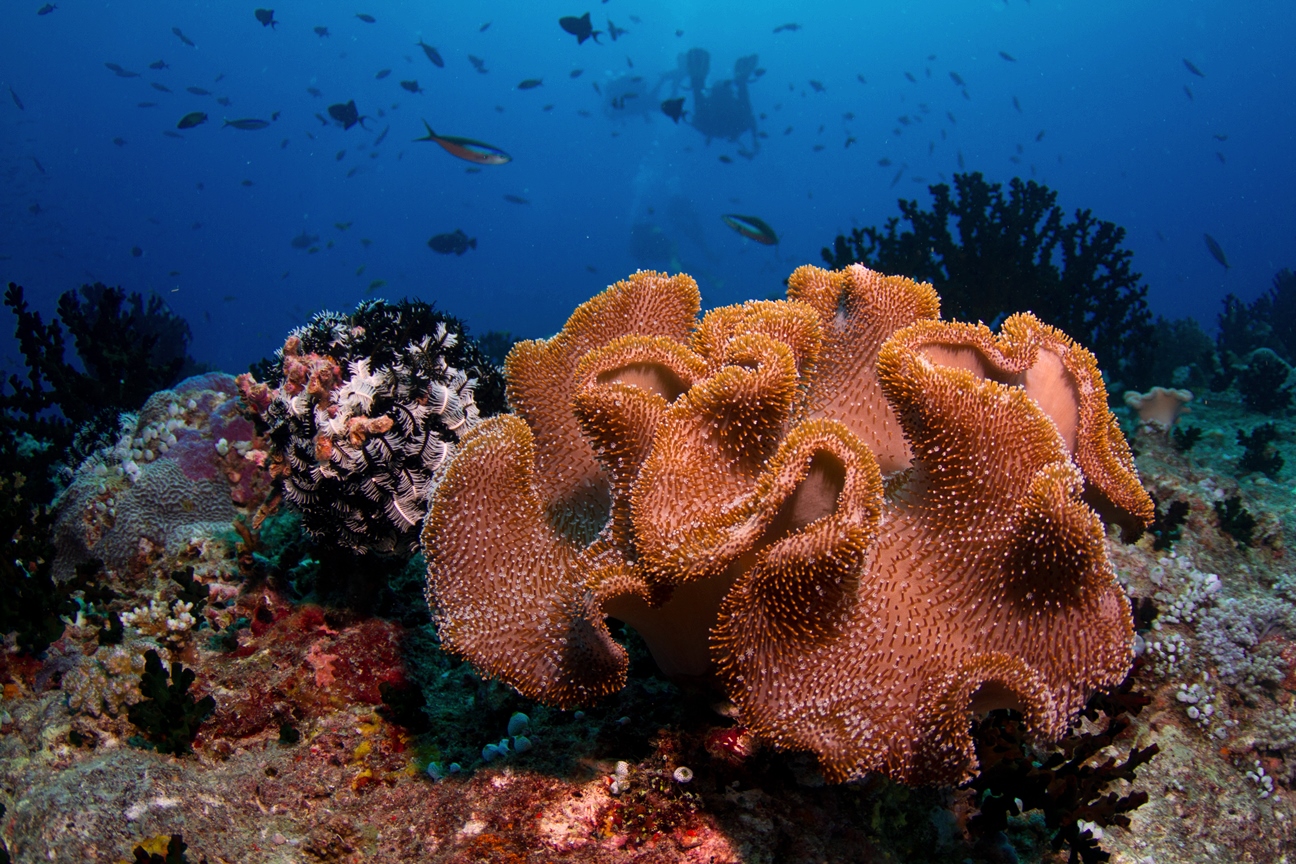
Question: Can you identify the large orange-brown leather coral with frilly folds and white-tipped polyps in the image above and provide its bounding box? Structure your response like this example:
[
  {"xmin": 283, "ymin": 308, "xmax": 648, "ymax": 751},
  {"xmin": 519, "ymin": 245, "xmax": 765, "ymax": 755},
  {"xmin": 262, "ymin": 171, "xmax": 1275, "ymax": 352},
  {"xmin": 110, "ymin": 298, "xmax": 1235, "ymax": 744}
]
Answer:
[{"xmin": 422, "ymin": 266, "xmax": 1152, "ymax": 784}]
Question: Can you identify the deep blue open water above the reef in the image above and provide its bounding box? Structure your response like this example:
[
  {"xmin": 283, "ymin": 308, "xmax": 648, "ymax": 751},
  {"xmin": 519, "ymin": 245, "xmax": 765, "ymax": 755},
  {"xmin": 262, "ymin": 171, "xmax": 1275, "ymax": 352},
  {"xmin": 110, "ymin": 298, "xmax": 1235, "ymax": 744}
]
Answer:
[{"xmin": 0, "ymin": 0, "xmax": 1296, "ymax": 372}]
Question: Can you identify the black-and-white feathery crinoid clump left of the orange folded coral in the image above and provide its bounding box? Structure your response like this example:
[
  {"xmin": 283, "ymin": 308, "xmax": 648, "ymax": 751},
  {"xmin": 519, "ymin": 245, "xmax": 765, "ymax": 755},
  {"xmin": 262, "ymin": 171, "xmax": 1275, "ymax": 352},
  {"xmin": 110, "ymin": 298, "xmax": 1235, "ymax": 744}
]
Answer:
[{"xmin": 238, "ymin": 301, "xmax": 504, "ymax": 554}]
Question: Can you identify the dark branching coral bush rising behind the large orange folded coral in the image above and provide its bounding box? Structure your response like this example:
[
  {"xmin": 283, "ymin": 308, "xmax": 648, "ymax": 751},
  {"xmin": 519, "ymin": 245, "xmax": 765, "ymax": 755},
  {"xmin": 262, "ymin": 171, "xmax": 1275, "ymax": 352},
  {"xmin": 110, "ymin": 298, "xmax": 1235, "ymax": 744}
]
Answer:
[{"xmin": 822, "ymin": 174, "xmax": 1152, "ymax": 386}]
